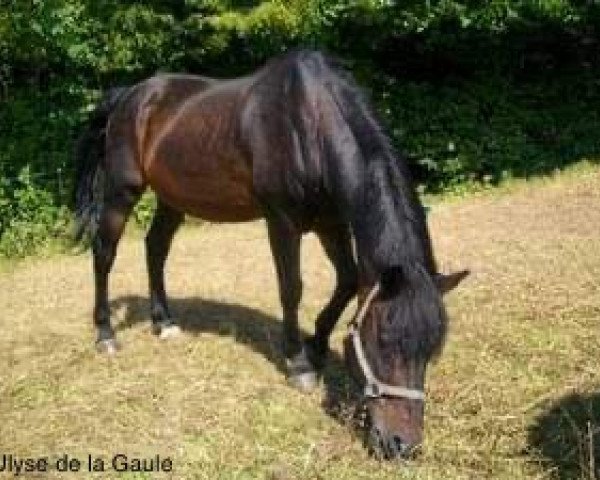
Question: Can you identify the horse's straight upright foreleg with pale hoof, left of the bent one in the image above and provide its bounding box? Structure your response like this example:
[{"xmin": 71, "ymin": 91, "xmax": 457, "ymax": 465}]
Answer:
[{"xmin": 267, "ymin": 218, "xmax": 317, "ymax": 390}]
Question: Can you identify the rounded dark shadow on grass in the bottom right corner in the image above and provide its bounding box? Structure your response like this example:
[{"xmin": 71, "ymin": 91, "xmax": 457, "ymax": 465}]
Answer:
[{"xmin": 528, "ymin": 393, "xmax": 600, "ymax": 480}]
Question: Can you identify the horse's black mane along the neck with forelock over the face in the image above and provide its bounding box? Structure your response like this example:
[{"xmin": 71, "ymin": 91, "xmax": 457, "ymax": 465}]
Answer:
[{"xmin": 276, "ymin": 52, "xmax": 447, "ymax": 358}]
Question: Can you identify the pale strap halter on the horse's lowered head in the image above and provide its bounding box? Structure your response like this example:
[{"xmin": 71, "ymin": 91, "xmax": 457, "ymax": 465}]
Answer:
[{"xmin": 348, "ymin": 283, "xmax": 425, "ymax": 401}]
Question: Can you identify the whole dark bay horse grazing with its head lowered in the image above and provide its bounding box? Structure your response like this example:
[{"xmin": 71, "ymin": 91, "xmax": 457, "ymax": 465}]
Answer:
[{"xmin": 75, "ymin": 51, "xmax": 466, "ymax": 458}]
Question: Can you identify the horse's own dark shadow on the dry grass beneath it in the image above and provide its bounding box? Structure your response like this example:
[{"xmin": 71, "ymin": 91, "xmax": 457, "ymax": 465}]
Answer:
[{"xmin": 111, "ymin": 296, "xmax": 360, "ymax": 434}]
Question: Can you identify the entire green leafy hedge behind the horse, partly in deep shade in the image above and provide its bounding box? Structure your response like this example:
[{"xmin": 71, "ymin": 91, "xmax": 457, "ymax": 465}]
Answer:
[{"xmin": 0, "ymin": 0, "xmax": 600, "ymax": 254}]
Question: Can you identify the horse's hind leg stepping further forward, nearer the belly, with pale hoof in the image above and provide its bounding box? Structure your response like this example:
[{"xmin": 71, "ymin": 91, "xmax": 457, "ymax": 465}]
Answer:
[{"xmin": 146, "ymin": 200, "xmax": 184, "ymax": 338}]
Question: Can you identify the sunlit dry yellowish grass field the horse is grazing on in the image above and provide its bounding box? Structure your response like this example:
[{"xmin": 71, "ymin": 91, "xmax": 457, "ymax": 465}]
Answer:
[{"xmin": 0, "ymin": 166, "xmax": 600, "ymax": 480}]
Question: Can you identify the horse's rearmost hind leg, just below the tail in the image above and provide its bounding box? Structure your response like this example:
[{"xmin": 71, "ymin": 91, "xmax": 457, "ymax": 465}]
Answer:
[{"xmin": 92, "ymin": 189, "xmax": 140, "ymax": 353}]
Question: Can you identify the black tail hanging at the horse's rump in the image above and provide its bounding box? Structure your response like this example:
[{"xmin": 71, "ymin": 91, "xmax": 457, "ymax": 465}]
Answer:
[{"xmin": 73, "ymin": 87, "xmax": 128, "ymax": 242}]
